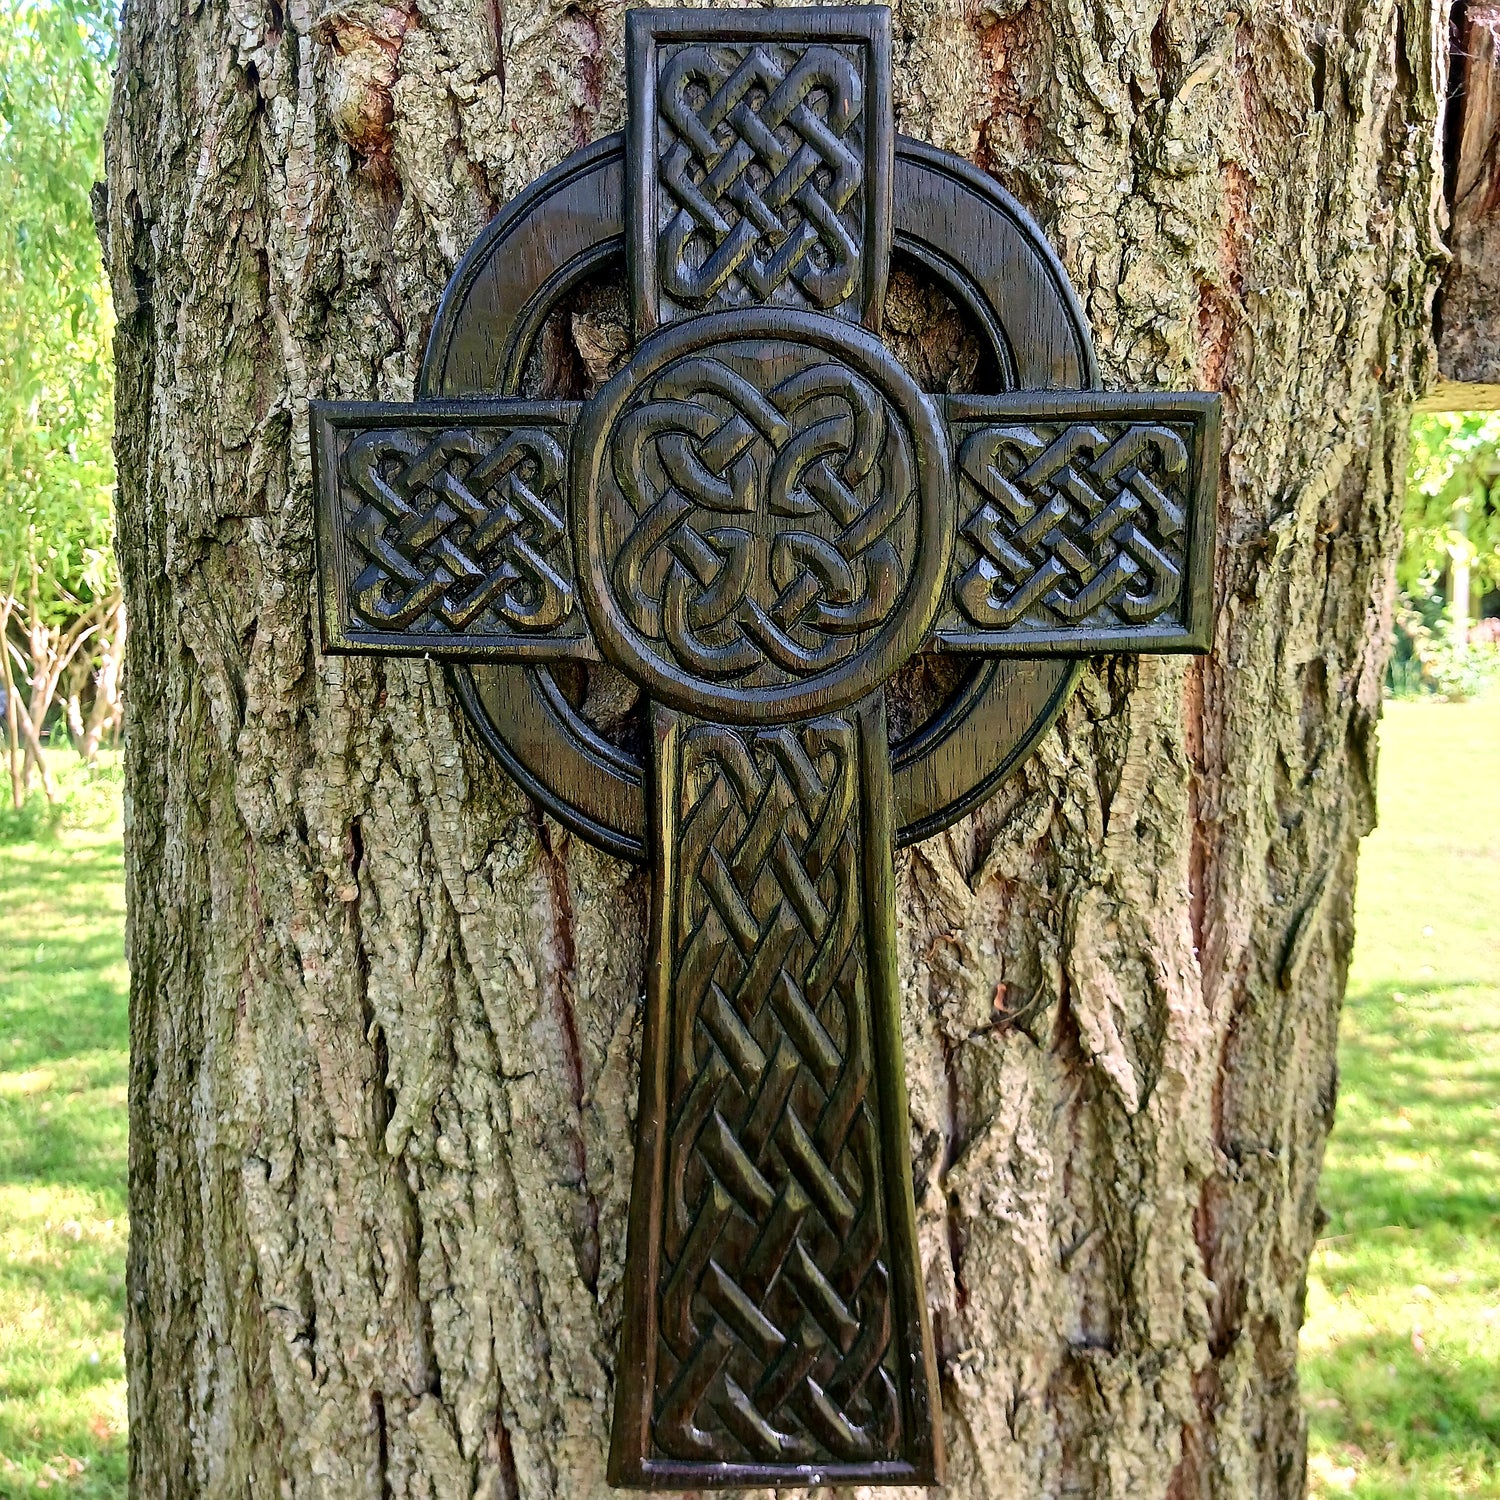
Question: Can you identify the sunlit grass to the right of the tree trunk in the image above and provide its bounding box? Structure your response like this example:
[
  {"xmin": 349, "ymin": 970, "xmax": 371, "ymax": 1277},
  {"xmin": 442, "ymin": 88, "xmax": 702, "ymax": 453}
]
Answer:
[{"xmin": 1302, "ymin": 701, "xmax": 1500, "ymax": 1500}]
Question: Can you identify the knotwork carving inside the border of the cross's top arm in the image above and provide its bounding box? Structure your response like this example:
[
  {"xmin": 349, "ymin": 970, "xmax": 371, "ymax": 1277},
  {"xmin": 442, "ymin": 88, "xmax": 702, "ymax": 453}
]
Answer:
[{"xmin": 657, "ymin": 44, "xmax": 866, "ymax": 309}]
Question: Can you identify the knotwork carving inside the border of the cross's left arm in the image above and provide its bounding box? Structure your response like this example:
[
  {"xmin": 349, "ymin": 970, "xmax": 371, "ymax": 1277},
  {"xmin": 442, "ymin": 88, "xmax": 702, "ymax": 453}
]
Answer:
[{"xmin": 341, "ymin": 428, "xmax": 573, "ymax": 636}]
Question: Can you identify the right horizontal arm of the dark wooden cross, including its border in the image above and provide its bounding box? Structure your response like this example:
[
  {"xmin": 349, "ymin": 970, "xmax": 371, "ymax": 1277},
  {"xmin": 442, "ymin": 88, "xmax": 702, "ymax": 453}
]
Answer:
[{"xmin": 933, "ymin": 392, "xmax": 1220, "ymax": 657}]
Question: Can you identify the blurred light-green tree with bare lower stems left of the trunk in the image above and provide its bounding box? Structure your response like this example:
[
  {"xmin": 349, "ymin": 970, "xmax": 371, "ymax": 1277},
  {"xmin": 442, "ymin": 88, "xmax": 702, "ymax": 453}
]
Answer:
[{"xmin": 0, "ymin": 0, "xmax": 125, "ymax": 807}]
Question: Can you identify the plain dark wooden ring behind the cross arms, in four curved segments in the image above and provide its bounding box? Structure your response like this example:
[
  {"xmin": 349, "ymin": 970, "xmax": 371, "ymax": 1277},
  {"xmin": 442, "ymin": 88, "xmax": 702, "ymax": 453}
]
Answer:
[{"xmin": 419, "ymin": 135, "xmax": 1098, "ymax": 860}]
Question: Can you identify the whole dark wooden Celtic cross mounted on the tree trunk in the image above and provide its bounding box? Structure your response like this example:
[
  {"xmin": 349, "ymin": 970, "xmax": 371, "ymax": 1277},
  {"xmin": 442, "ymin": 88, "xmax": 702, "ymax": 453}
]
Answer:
[{"xmin": 312, "ymin": 8, "xmax": 1218, "ymax": 1490}]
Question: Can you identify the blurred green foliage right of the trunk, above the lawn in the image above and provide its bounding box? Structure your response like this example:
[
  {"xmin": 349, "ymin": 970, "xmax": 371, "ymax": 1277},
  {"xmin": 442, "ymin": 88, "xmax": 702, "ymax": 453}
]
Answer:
[{"xmin": 1391, "ymin": 411, "xmax": 1500, "ymax": 699}]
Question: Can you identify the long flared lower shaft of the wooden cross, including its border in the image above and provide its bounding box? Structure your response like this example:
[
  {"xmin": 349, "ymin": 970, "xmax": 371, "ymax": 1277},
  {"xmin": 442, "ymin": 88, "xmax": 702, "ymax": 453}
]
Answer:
[{"xmin": 611, "ymin": 693, "xmax": 939, "ymax": 1482}]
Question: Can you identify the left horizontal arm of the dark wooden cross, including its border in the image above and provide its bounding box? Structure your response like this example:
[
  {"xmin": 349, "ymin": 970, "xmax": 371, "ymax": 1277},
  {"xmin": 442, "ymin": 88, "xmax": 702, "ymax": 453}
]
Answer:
[{"xmin": 312, "ymin": 401, "xmax": 597, "ymax": 662}]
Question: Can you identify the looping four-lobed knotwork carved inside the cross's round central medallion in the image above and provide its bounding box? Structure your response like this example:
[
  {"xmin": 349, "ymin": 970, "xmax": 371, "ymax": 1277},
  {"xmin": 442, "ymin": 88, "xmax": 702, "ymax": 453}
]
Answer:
[{"xmin": 611, "ymin": 345, "xmax": 915, "ymax": 684}]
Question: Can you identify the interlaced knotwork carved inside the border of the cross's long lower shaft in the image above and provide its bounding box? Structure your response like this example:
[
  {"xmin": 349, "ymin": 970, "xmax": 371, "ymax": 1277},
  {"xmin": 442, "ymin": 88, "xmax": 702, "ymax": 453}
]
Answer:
[{"xmin": 653, "ymin": 717, "xmax": 900, "ymax": 1464}]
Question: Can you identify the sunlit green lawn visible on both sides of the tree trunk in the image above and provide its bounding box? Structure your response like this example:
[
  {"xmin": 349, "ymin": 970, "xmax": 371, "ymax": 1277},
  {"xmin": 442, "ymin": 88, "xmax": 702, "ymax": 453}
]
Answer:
[{"xmin": 0, "ymin": 702, "xmax": 1500, "ymax": 1500}]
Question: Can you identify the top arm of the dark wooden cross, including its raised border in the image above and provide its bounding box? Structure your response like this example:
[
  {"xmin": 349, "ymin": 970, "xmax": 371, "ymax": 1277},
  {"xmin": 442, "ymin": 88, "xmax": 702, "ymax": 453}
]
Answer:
[{"xmin": 630, "ymin": 8, "xmax": 891, "ymax": 329}]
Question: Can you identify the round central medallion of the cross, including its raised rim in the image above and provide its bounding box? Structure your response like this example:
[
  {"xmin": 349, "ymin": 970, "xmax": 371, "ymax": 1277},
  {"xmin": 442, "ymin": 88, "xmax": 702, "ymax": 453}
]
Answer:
[{"xmin": 572, "ymin": 309, "xmax": 954, "ymax": 723}]
